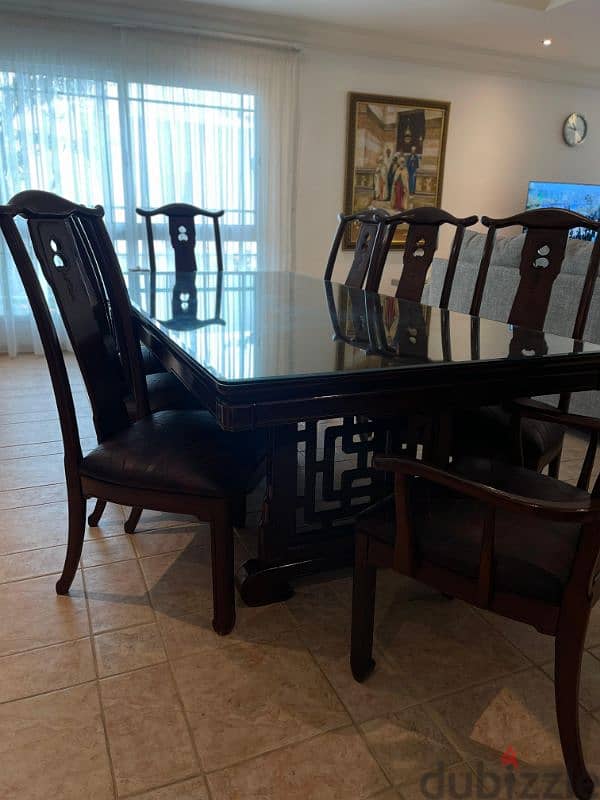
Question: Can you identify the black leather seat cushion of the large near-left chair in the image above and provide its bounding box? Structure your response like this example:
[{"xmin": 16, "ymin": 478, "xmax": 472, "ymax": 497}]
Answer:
[{"xmin": 81, "ymin": 411, "xmax": 266, "ymax": 497}]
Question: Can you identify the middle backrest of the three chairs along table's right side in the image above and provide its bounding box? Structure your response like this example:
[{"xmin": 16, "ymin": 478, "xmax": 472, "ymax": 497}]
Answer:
[{"xmin": 367, "ymin": 207, "xmax": 478, "ymax": 308}]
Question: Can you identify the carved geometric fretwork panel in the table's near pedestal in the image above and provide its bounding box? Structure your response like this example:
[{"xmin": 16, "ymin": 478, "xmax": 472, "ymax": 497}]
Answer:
[{"xmin": 297, "ymin": 417, "xmax": 392, "ymax": 536}]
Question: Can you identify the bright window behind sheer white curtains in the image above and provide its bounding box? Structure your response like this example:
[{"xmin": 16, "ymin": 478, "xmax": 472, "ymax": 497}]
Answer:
[{"xmin": 0, "ymin": 71, "xmax": 257, "ymax": 282}]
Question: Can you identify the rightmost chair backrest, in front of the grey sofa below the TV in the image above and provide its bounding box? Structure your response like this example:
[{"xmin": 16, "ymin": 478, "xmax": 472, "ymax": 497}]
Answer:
[{"xmin": 470, "ymin": 208, "xmax": 600, "ymax": 339}]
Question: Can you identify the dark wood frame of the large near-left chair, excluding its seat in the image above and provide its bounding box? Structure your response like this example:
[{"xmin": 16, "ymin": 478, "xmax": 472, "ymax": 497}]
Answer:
[{"xmin": 0, "ymin": 191, "xmax": 248, "ymax": 635}]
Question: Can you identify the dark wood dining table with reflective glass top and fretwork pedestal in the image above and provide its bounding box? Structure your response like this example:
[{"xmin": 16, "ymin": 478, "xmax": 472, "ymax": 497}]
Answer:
[{"xmin": 126, "ymin": 271, "xmax": 600, "ymax": 605}]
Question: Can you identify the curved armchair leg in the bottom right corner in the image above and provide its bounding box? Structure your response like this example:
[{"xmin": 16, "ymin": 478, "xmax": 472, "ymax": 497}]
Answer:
[{"xmin": 554, "ymin": 611, "xmax": 594, "ymax": 800}]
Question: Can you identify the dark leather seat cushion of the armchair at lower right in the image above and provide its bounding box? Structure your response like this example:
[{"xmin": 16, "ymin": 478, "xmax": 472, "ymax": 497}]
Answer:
[{"xmin": 357, "ymin": 459, "xmax": 589, "ymax": 604}]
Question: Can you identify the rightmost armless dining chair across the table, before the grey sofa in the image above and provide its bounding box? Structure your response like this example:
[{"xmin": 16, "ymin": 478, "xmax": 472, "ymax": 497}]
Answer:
[{"xmin": 454, "ymin": 208, "xmax": 600, "ymax": 477}]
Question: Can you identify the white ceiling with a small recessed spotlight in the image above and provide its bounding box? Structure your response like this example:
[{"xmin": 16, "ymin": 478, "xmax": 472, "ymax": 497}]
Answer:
[{"xmin": 182, "ymin": 0, "xmax": 600, "ymax": 69}]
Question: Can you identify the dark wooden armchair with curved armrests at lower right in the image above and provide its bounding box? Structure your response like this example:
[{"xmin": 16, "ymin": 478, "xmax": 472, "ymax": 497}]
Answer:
[{"xmin": 351, "ymin": 416, "xmax": 600, "ymax": 800}]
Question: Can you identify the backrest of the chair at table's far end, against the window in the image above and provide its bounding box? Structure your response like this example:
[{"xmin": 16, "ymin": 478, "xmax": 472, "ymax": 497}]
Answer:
[{"xmin": 136, "ymin": 203, "xmax": 225, "ymax": 272}]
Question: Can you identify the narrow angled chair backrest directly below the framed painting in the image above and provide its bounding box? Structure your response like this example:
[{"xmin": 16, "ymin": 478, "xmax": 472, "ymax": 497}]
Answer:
[{"xmin": 324, "ymin": 208, "xmax": 388, "ymax": 289}]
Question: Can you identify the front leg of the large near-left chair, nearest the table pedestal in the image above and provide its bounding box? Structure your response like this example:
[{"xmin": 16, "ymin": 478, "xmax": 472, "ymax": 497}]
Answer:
[{"xmin": 210, "ymin": 501, "xmax": 235, "ymax": 636}]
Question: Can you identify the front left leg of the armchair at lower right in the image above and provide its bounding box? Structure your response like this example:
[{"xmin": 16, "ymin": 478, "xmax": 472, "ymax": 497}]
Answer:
[{"xmin": 350, "ymin": 533, "xmax": 377, "ymax": 683}]
